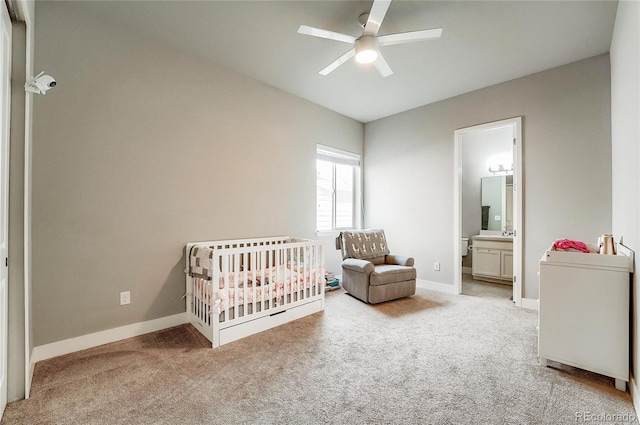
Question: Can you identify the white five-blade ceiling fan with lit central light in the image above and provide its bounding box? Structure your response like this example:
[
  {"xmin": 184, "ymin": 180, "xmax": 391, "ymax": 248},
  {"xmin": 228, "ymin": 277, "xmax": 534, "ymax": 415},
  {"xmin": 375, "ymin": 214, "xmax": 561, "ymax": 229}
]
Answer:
[{"xmin": 298, "ymin": 0, "xmax": 442, "ymax": 77}]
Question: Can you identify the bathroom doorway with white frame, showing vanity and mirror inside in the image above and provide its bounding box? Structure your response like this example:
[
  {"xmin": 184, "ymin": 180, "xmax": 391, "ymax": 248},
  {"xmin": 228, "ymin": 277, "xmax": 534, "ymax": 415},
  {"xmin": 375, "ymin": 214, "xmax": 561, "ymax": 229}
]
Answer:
[{"xmin": 454, "ymin": 117, "xmax": 523, "ymax": 307}]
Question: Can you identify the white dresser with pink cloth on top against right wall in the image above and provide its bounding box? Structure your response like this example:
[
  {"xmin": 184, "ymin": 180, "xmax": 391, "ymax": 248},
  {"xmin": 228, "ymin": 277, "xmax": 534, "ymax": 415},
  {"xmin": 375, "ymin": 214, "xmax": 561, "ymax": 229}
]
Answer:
[{"xmin": 538, "ymin": 245, "xmax": 633, "ymax": 391}]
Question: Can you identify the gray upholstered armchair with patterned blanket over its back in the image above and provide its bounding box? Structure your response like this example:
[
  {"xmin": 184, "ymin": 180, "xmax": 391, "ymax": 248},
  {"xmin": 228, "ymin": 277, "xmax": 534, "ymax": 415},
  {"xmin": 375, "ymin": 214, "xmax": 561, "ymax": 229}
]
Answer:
[{"xmin": 336, "ymin": 229, "xmax": 416, "ymax": 304}]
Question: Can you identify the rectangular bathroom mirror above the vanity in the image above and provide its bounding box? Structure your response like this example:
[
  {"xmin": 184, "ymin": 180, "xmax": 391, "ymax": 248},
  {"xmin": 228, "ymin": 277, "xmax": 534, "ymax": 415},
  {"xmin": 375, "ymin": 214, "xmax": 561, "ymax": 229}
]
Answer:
[{"xmin": 481, "ymin": 175, "xmax": 513, "ymax": 232}]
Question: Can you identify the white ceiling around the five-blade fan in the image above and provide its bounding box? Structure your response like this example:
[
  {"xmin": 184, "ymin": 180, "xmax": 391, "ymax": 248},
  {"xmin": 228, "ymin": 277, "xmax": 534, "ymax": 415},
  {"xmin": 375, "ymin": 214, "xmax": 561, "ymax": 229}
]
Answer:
[{"xmin": 67, "ymin": 0, "xmax": 617, "ymax": 122}]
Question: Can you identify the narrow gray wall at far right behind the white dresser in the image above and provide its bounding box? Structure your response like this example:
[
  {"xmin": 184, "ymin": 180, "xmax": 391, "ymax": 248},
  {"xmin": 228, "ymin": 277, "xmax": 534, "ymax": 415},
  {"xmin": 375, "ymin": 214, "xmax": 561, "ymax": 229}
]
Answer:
[{"xmin": 611, "ymin": 1, "xmax": 640, "ymax": 397}]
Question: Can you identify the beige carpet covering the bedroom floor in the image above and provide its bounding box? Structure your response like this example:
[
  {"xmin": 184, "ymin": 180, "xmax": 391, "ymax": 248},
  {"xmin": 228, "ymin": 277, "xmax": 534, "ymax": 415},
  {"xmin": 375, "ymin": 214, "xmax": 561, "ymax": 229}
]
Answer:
[{"xmin": 2, "ymin": 288, "xmax": 635, "ymax": 424}]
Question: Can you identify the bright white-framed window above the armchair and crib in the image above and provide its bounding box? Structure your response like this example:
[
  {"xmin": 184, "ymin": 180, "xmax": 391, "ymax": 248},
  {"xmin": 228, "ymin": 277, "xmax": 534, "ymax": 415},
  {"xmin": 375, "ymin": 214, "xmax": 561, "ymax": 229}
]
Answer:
[{"xmin": 316, "ymin": 145, "xmax": 360, "ymax": 232}]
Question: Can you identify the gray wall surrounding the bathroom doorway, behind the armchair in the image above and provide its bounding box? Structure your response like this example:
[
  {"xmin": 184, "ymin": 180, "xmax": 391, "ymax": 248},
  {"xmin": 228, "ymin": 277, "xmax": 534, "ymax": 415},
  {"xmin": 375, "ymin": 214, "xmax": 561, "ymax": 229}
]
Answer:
[{"xmin": 364, "ymin": 54, "xmax": 611, "ymax": 299}]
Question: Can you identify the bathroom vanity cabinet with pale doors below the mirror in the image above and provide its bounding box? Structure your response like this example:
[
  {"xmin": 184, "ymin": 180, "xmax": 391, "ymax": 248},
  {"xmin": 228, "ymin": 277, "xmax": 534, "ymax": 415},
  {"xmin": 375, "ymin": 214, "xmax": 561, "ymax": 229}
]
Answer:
[{"xmin": 471, "ymin": 235, "xmax": 513, "ymax": 284}]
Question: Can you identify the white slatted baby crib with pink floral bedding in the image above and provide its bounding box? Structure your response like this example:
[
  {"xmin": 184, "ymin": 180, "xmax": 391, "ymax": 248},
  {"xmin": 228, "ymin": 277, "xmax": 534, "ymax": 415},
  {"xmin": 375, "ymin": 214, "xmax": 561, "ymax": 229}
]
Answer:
[{"xmin": 185, "ymin": 236, "xmax": 325, "ymax": 348}]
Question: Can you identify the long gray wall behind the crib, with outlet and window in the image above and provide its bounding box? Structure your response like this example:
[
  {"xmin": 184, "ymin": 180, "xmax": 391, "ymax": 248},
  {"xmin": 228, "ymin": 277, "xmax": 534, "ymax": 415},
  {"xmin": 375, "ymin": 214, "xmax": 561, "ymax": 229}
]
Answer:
[{"xmin": 32, "ymin": 2, "xmax": 364, "ymax": 346}]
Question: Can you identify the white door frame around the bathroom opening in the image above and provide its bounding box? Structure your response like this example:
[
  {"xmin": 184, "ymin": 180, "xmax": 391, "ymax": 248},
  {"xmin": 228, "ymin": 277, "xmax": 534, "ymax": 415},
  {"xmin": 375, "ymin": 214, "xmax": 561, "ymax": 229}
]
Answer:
[{"xmin": 453, "ymin": 117, "xmax": 524, "ymax": 307}]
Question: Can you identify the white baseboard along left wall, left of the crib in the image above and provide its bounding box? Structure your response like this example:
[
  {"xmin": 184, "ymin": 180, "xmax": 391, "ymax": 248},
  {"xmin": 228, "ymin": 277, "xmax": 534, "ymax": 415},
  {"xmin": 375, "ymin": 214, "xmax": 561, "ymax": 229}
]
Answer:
[{"xmin": 31, "ymin": 312, "xmax": 187, "ymax": 367}]
